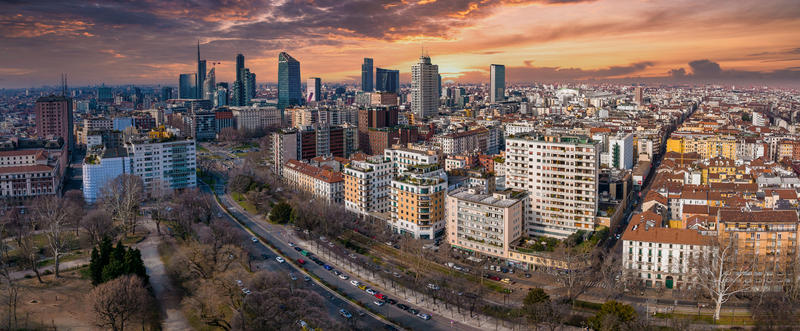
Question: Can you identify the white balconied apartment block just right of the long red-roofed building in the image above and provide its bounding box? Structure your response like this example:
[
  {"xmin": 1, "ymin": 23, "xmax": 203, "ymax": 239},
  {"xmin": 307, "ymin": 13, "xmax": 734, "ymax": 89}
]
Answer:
[{"xmin": 344, "ymin": 155, "xmax": 394, "ymax": 215}]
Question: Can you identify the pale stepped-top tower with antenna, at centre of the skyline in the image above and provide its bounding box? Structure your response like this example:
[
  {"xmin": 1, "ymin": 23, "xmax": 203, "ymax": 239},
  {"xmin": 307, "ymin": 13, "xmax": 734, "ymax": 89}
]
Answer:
[{"xmin": 411, "ymin": 55, "xmax": 440, "ymax": 119}]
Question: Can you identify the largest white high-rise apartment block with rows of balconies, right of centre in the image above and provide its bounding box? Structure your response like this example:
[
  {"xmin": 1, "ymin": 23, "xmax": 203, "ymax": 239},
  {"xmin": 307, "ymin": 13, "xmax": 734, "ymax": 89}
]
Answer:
[{"xmin": 505, "ymin": 132, "xmax": 601, "ymax": 239}]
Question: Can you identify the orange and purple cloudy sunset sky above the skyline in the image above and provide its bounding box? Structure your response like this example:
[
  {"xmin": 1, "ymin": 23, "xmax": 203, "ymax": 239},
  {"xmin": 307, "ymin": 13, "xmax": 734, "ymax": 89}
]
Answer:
[{"xmin": 0, "ymin": 0, "xmax": 800, "ymax": 88}]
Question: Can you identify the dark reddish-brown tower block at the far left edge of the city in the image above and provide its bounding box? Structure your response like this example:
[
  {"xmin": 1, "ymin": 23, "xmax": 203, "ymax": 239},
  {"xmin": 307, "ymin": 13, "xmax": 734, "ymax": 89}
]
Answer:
[{"xmin": 36, "ymin": 95, "xmax": 75, "ymax": 152}]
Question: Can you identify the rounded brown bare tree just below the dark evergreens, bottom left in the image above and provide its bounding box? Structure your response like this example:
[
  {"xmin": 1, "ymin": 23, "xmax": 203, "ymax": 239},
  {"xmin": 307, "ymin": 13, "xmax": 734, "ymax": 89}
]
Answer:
[{"xmin": 89, "ymin": 275, "xmax": 152, "ymax": 331}]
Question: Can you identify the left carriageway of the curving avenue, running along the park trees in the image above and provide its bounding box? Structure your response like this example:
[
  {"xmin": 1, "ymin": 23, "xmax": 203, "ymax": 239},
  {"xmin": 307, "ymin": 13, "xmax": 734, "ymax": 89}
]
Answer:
[{"xmin": 201, "ymin": 184, "xmax": 396, "ymax": 330}]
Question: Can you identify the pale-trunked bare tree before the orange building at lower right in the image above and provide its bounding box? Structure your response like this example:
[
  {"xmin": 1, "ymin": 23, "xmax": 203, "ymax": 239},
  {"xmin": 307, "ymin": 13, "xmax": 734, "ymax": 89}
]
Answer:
[{"xmin": 690, "ymin": 236, "xmax": 751, "ymax": 321}]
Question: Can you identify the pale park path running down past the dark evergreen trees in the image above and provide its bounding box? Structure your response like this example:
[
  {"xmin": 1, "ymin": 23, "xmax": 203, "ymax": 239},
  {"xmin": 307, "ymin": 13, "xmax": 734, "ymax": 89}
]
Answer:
[{"xmin": 136, "ymin": 221, "xmax": 192, "ymax": 331}]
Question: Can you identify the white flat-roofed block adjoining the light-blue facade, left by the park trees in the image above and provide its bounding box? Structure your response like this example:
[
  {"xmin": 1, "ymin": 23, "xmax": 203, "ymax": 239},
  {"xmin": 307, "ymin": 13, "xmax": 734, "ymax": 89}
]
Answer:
[{"xmin": 125, "ymin": 137, "xmax": 197, "ymax": 192}]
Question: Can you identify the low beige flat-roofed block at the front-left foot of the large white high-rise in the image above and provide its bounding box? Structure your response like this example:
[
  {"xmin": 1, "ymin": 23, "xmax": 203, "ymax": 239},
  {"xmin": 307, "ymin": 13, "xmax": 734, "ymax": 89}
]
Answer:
[{"xmin": 445, "ymin": 187, "xmax": 528, "ymax": 259}]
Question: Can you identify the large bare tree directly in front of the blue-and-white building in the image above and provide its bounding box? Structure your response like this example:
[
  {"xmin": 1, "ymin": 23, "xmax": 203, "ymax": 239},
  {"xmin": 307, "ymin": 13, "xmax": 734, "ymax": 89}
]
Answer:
[{"xmin": 100, "ymin": 174, "xmax": 144, "ymax": 234}]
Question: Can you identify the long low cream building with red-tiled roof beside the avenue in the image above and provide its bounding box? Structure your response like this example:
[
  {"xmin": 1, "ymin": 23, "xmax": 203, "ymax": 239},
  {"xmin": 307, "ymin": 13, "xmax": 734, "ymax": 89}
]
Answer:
[{"xmin": 283, "ymin": 160, "xmax": 344, "ymax": 204}]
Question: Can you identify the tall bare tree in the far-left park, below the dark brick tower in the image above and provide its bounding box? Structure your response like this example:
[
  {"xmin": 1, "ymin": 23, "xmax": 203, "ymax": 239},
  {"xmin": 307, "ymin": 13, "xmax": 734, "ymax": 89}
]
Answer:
[{"xmin": 31, "ymin": 195, "xmax": 76, "ymax": 278}]
